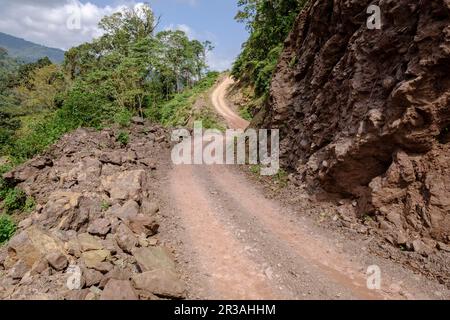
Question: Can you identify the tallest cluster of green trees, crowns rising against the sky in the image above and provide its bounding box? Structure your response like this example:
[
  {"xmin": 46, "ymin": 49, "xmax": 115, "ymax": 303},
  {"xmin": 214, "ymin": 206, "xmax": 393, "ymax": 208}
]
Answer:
[{"xmin": 64, "ymin": 5, "xmax": 211, "ymax": 119}]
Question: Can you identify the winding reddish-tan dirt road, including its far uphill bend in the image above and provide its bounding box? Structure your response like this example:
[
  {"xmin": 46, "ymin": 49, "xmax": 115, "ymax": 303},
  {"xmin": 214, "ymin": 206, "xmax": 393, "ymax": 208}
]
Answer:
[{"xmin": 166, "ymin": 78, "xmax": 449, "ymax": 299}]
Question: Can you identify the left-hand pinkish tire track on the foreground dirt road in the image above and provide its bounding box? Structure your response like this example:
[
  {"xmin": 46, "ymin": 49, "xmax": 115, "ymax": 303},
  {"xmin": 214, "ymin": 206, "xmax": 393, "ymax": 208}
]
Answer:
[{"xmin": 170, "ymin": 162, "xmax": 282, "ymax": 300}]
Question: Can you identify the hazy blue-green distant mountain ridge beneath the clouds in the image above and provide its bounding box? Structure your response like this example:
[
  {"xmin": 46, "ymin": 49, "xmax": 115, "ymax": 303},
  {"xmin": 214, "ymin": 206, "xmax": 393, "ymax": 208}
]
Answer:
[{"xmin": 0, "ymin": 32, "xmax": 64, "ymax": 63}]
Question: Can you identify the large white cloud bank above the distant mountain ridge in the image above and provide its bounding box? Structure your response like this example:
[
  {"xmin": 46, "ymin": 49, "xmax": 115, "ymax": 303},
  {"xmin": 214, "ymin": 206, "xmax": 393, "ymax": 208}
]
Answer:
[{"xmin": 0, "ymin": 0, "xmax": 142, "ymax": 49}]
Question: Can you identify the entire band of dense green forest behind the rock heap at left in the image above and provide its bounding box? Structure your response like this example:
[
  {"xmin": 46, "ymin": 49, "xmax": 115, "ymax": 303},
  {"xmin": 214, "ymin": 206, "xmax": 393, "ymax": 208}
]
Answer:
[{"xmin": 0, "ymin": 5, "xmax": 212, "ymax": 163}]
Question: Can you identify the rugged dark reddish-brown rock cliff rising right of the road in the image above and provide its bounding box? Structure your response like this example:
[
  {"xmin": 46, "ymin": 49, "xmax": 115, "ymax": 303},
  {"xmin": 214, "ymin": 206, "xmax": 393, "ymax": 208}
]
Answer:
[{"xmin": 260, "ymin": 0, "xmax": 450, "ymax": 245}]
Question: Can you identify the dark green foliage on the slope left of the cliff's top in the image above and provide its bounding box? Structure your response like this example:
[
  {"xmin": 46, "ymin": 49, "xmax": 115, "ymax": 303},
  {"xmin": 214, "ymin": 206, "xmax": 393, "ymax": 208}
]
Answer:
[{"xmin": 232, "ymin": 0, "xmax": 307, "ymax": 96}]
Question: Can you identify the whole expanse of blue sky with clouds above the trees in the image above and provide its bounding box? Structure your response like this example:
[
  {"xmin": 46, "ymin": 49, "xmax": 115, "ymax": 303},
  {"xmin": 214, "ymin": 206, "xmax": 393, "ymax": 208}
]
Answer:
[{"xmin": 0, "ymin": 0, "xmax": 248, "ymax": 70}]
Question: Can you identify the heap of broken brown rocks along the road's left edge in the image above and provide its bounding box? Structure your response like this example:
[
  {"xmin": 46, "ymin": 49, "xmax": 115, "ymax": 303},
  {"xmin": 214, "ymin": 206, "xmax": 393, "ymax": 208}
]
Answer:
[{"xmin": 0, "ymin": 119, "xmax": 186, "ymax": 300}]
